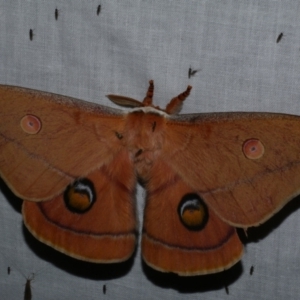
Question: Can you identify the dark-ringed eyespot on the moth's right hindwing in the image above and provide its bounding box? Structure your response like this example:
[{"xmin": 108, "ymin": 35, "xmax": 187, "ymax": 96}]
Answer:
[{"xmin": 178, "ymin": 194, "xmax": 208, "ymax": 230}]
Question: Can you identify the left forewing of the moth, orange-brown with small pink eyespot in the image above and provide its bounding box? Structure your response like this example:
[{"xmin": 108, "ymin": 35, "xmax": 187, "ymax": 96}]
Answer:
[{"xmin": 0, "ymin": 86, "xmax": 124, "ymax": 201}]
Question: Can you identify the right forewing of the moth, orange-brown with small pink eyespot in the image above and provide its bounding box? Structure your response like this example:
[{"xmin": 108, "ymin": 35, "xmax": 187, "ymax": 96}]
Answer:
[{"xmin": 162, "ymin": 113, "xmax": 300, "ymax": 228}]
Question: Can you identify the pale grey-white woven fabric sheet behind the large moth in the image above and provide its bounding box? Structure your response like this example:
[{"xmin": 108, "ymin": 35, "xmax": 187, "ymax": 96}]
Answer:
[{"xmin": 0, "ymin": 0, "xmax": 300, "ymax": 300}]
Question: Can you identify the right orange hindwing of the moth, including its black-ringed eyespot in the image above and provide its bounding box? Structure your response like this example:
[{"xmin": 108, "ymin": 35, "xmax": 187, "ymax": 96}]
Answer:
[{"xmin": 142, "ymin": 160, "xmax": 243, "ymax": 276}]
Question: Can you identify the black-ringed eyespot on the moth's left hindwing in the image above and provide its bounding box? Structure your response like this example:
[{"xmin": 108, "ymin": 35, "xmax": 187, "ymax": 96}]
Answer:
[{"xmin": 64, "ymin": 178, "xmax": 96, "ymax": 213}]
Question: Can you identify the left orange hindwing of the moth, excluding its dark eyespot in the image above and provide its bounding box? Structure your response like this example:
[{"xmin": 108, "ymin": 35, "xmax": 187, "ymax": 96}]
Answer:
[{"xmin": 22, "ymin": 151, "xmax": 136, "ymax": 263}]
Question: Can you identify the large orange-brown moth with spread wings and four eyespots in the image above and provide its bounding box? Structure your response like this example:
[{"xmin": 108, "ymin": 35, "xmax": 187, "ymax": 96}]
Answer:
[{"xmin": 0, "ymin": 81, "xmax": 300, "ymax": 276}]
